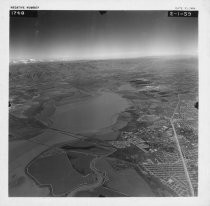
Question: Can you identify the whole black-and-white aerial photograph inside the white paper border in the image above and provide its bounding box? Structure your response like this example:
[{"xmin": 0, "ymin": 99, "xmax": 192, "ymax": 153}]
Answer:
[{"xmin": 8, "ymin": 10, "xmax": 199, "ymax": 197}]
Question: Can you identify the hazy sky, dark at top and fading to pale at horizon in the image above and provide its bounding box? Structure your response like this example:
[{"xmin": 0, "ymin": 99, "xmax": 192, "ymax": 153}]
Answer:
[{"xmin": 10, "ymin": 11, "xmax": 198, "ymax": 60}]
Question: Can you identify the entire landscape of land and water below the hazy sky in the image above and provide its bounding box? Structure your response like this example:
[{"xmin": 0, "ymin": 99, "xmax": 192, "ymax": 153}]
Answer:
[{"xmin": 9, "ymin": 56, "xmax": 198, "ymax": 197}]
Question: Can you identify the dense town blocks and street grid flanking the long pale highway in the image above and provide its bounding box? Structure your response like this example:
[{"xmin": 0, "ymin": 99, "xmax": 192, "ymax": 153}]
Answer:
[{"xmin": 110, "ymin": 99, "xmax": 198, "ymax": 196}]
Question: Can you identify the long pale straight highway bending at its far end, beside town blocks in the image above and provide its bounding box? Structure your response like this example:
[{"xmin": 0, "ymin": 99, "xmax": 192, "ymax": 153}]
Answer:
[{"xmin": 170, "ymin": 95, "xmax": 194, "ymax": 196}]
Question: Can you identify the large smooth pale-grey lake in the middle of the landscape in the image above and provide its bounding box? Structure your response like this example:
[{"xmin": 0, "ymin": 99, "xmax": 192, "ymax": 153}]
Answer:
[{"xmin": 52, "ymin": 92, "xmax": 130, "ymax": 133}]
